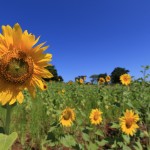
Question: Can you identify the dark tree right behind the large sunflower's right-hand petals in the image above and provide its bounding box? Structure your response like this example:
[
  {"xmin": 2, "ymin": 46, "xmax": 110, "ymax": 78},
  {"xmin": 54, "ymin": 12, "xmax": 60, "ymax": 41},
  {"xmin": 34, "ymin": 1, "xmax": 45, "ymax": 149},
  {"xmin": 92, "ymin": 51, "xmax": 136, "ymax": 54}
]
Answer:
[{"xmin": 44, "ymin": 65, "xmax": 63, "ymax": 81}]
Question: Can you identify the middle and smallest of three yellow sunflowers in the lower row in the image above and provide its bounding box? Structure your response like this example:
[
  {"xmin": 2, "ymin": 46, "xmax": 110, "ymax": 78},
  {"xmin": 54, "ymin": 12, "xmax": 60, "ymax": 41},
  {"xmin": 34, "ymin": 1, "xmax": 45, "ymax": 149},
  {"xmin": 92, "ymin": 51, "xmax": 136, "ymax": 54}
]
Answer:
[{"xmin": 89, "ymin": 109, "xmax": 102, "ymax": 125}]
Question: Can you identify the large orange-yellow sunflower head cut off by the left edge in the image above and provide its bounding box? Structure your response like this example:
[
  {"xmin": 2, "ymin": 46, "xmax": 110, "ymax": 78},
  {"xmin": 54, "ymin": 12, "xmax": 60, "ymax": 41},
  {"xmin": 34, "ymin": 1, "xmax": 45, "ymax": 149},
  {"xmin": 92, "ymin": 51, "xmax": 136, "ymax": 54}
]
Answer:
[{"xmin": 0, "ymin": 23, "xmax": 52, "ymax": 105}]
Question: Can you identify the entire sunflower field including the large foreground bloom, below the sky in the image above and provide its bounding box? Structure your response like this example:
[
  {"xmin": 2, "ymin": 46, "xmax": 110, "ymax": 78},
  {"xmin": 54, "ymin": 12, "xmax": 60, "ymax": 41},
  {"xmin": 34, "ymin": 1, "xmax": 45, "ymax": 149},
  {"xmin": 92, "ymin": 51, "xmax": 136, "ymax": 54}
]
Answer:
[{"xmin": 0, "ymin": 23, "xmax": 150, "ymax": 150}]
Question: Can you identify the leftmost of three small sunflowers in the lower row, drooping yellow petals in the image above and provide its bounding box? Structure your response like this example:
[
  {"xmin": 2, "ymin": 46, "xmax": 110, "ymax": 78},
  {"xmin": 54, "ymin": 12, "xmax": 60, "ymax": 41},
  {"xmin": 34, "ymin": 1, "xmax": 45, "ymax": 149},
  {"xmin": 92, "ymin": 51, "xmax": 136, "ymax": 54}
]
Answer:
[{"xmin": 60, "ymin": 107, "xmax": 75, "ymax": 127}]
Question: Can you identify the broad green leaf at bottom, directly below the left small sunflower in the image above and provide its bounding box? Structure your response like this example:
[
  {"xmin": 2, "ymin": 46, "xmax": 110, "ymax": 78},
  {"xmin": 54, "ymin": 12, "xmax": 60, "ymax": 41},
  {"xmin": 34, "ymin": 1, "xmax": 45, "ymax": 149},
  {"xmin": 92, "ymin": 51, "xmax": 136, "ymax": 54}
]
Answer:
[{"xmin": 60, "ymin": 135, "xmax": 76, "ymax": 147}]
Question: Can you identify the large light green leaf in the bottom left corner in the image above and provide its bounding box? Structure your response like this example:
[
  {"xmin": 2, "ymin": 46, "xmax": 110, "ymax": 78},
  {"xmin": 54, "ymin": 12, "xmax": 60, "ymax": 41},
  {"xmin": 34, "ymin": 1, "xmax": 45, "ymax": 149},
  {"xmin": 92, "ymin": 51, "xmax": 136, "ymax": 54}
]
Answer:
[{"xmin": 0, "ymin": 132, "xmax": 18, "ymax": 150}]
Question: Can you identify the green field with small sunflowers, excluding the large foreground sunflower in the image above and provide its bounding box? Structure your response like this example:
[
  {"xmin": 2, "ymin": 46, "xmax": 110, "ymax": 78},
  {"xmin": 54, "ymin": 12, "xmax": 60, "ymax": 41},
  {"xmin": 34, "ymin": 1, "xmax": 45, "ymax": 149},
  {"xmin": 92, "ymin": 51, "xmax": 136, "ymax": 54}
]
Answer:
[{"xmin": 0, "ymin": 77, "xmax": 150, "ymax": 150}]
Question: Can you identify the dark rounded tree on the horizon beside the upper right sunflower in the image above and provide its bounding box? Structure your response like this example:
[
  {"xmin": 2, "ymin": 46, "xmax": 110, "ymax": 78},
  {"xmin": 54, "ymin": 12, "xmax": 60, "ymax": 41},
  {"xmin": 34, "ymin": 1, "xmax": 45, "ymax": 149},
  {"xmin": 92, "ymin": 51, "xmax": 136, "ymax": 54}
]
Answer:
[{"xmin": 111, "ymin": 67, "xmax": 129, "ymax": 84}]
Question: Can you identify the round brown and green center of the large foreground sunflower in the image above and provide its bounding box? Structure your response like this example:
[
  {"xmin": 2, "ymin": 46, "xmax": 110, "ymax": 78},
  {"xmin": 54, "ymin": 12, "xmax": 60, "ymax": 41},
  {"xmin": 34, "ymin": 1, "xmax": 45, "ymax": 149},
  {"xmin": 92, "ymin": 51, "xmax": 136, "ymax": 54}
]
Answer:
[{"xmin": 0, "ymin": 51, "xmax": 33, "ymax": 84}]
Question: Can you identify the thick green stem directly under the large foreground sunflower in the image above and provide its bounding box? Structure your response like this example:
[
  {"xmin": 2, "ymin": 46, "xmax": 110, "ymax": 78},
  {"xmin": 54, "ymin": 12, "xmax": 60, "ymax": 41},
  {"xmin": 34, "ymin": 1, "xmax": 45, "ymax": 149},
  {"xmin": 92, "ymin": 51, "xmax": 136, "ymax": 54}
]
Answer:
[{"xmin": 5, "ymin": 104, "xmax": 12, "ymax": 134}]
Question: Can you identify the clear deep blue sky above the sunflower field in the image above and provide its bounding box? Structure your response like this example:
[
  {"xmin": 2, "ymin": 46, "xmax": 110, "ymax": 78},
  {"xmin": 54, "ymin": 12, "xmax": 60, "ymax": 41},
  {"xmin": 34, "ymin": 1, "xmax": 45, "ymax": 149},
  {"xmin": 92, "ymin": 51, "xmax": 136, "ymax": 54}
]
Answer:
[{"xmin": 0, "ymin": 0, "xmax": 150, "ymax": 81}]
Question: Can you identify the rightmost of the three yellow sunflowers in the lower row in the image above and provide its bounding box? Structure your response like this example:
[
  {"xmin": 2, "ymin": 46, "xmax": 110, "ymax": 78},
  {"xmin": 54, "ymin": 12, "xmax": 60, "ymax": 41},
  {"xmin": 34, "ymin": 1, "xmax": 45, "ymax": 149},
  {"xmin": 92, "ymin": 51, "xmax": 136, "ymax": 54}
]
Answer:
[{"xmin": 119, "ymin": 109, "xmax": 139, "ymax": 136}]
